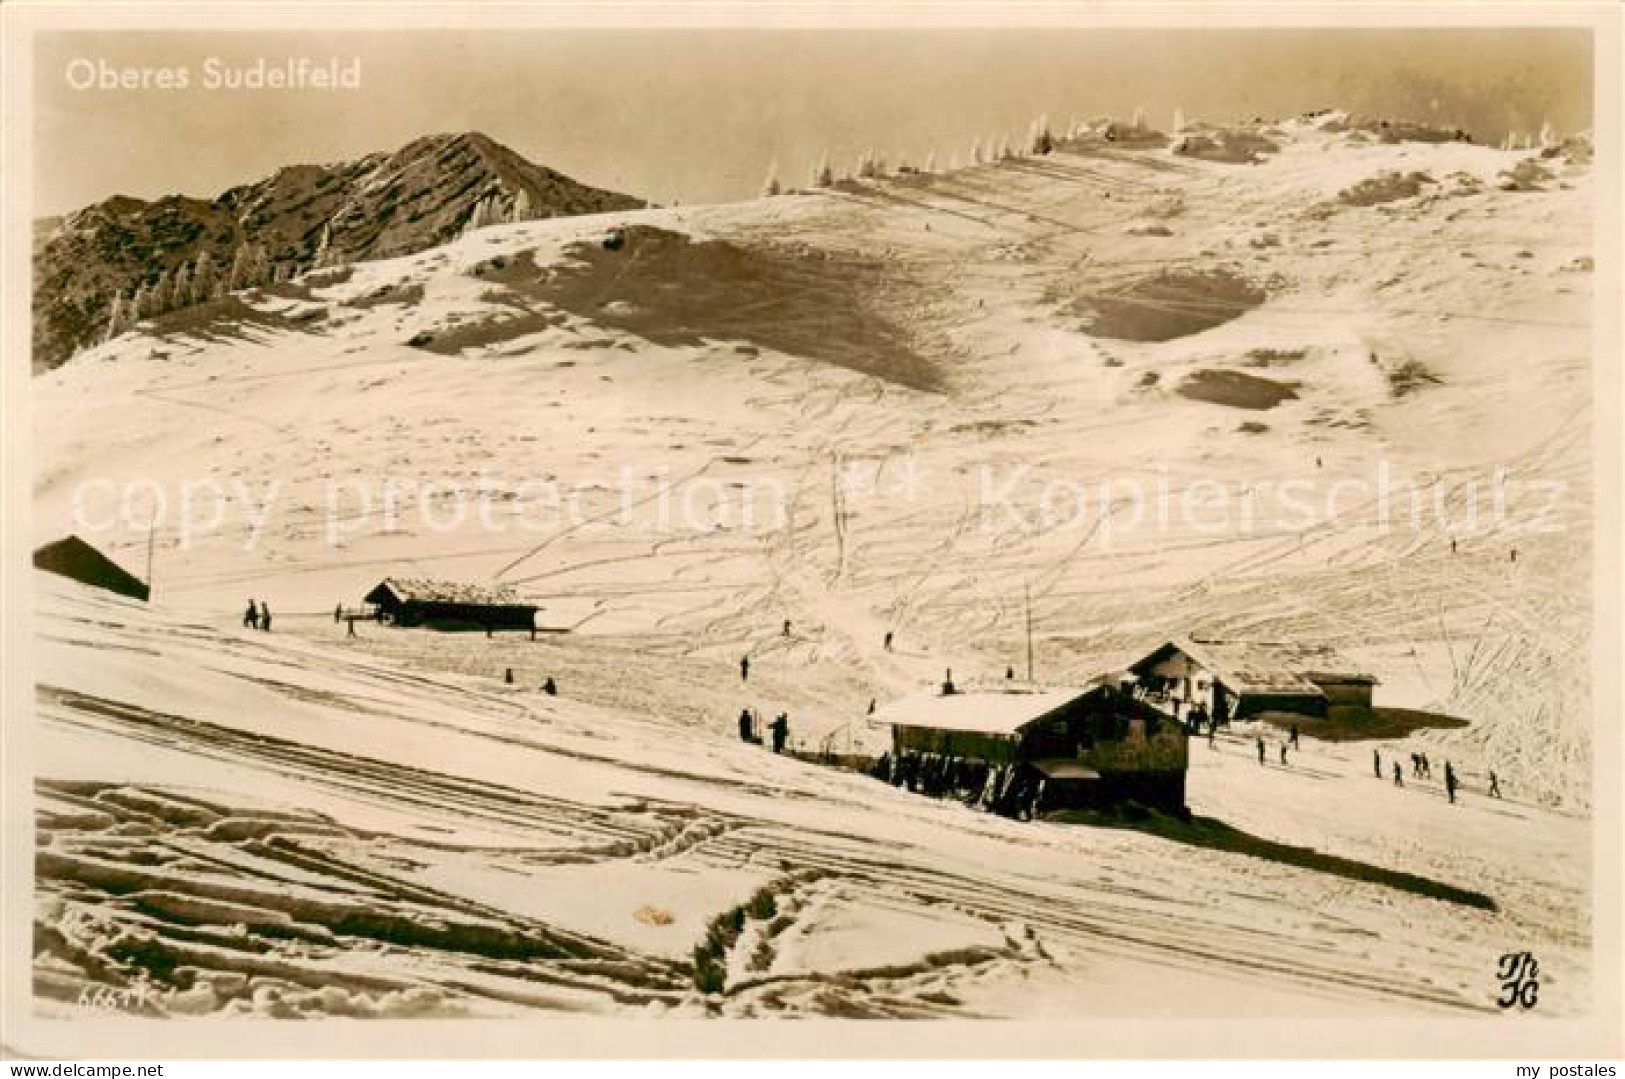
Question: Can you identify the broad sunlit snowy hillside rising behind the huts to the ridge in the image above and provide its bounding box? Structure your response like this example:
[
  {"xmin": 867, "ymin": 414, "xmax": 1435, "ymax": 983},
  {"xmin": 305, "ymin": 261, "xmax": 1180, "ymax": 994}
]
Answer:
[{"xmin": 34, "ymin": 117, "xmax": 1591, "ymax": 804}]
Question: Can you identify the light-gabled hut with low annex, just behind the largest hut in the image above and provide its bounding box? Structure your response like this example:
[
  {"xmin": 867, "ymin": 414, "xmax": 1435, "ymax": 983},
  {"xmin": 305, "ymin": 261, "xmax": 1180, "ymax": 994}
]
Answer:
[{"xmin": 1129, "ymin": 637, "xmax": 1376, "ymax": 723}]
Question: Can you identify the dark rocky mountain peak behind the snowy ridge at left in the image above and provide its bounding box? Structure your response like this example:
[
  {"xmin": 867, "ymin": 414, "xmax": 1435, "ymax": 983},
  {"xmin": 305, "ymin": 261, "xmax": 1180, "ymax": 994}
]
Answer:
[{"xmin": 34, "ymin": 132, "xmax": 642, "ymax": 371}]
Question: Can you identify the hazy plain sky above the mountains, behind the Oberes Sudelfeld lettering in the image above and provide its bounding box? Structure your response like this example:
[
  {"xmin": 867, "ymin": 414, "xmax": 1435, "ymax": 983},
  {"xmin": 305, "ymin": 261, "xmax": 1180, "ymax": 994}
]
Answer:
[{"xmin": 34, "ymin": 29, "xmax": 1591, "ymax": 215}]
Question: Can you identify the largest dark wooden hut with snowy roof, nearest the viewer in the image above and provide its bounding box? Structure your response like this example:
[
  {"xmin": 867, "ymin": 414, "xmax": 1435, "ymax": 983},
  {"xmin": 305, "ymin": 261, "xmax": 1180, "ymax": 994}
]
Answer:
[{"xmin": 874, "ymin": 684, "xmax": 1188, "ymax": 813}]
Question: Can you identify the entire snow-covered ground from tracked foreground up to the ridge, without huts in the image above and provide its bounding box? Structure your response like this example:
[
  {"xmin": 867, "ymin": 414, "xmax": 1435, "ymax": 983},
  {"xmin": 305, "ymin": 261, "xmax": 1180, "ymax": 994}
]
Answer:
[{"xmin": 33, "ymin": 120, "xmax": 1593, "ymax": 1017}]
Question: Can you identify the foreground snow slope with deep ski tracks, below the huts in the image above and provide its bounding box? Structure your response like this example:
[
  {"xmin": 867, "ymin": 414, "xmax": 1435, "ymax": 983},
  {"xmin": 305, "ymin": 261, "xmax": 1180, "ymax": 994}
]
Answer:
[{"xmin": 36, "ymin": 577, "xmax": 1589, "ymax": 1017}]
